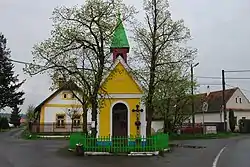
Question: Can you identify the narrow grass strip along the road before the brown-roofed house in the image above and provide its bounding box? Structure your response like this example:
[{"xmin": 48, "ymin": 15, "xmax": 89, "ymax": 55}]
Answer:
[{"xmin": 169, "ymin": 132, "xmax": 240, "ymax": 140}]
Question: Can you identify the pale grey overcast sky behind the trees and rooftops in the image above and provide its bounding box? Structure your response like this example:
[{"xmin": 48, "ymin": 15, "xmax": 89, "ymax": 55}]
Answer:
[{"xmin": 0, "ymin": 0, "xmax": 250, "ymax": 112}]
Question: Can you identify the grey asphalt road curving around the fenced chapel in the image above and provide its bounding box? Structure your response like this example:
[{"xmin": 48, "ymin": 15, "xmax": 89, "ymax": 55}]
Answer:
[{"xmin": 0, "ymin": 130, "xmax": 250, "ymax": 167}]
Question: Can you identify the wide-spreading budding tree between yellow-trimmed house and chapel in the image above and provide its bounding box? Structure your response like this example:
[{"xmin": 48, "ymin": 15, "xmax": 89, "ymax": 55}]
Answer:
[{"xmin": 25, "ymin": 0, "xmax": 134, "ymax": 135}]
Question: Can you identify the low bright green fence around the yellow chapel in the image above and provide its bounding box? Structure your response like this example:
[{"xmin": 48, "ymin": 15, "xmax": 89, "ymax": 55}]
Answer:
[{"xmin": 69, "ymin": 133, "xmax": 169, "ymax": 153}]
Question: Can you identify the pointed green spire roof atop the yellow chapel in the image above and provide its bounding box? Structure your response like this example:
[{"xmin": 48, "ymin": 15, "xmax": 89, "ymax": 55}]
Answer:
[{"xmin": 110, "ymin": 12, "xmax": 129, "ymax": 49}]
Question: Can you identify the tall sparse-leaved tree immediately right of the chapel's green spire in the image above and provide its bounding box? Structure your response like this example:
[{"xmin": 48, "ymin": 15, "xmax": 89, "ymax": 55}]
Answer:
[{"xmin": 133, "ymin": 0, "xmax": 196, "ymax": 135}]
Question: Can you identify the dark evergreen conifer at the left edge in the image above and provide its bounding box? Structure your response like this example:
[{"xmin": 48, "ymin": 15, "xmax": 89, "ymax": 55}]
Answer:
[{"xmin": 0, "ymin": 33, "xmax": 24, "ymax": 111}]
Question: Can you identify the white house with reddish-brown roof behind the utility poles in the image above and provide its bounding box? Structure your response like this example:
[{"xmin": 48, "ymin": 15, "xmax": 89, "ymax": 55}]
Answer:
[{"xmin": 190, "ymin": 87, "xmax": 250, "ymax": 131}]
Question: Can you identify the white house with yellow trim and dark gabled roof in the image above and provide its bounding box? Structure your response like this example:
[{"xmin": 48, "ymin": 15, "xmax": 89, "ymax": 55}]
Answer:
[{"xmin": 35, "ymin": 82, "xmax": 92, "ymax": 132}]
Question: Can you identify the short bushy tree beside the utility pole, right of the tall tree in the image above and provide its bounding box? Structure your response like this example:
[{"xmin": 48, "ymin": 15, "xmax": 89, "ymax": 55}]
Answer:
[{"xmin": 153, "ymin": 71, "xmax": 194, "ymax": 132}]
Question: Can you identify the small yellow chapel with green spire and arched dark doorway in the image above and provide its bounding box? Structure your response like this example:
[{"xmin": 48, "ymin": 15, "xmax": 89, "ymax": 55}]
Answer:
[{"xmin": 97, "ymin": 15, "xmax": 146, "ymax": 144}]
